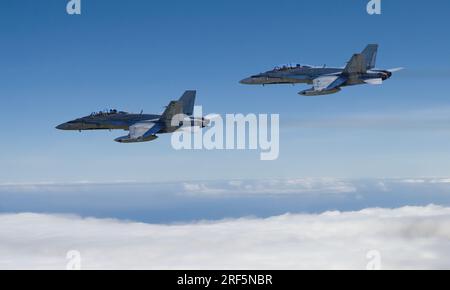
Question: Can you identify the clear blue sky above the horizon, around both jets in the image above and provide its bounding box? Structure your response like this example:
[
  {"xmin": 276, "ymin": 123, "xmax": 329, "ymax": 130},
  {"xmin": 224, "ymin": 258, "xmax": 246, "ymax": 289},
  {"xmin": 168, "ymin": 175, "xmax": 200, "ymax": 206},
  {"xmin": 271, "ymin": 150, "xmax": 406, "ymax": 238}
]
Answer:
[{"xmin": 0, "ymin": 0, "xmax": 450, "ymax": 183}]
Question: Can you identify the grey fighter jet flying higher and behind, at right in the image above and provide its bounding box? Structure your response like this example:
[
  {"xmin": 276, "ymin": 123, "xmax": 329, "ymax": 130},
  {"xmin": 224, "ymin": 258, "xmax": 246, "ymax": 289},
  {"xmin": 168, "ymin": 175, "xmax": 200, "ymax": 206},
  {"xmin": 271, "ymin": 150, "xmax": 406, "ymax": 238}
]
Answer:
[{"xmin": 240, "ymin": 44, "xmax": 403, "ymax": 96}]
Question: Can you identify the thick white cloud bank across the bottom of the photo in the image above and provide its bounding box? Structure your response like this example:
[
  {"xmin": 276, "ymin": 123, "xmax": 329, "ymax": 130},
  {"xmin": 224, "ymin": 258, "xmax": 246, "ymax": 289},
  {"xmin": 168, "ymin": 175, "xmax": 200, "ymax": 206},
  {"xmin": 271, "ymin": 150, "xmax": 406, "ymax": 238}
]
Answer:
[{"xmin": 0, "ymin": 205, "xmax": 450, "ymax": 269}]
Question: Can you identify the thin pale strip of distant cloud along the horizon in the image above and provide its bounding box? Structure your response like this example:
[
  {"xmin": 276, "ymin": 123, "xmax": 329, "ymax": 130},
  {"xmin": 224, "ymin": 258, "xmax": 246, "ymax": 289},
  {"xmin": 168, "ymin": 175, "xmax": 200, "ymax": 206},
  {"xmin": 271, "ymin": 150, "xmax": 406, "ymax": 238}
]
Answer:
[{"xmin": 0, "ymin": 177, "xmax": 450, "ymax": 195}]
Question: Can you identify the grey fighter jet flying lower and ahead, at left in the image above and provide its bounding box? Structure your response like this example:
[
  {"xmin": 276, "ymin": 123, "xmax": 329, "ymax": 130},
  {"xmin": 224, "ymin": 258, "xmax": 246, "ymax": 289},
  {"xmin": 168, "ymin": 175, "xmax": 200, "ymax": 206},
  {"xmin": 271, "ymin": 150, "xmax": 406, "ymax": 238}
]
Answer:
[{"xmin": 56, "ymin": 91, "xmax": 211, "ymax": 143}]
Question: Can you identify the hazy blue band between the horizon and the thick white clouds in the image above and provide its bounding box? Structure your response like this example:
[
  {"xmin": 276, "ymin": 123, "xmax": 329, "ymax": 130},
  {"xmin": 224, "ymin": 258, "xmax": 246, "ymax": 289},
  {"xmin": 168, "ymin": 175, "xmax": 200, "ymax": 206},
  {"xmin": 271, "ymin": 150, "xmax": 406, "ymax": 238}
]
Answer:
[{"xmin": 0, "ymin": 177, "xmax": 450, "ymax": 224}]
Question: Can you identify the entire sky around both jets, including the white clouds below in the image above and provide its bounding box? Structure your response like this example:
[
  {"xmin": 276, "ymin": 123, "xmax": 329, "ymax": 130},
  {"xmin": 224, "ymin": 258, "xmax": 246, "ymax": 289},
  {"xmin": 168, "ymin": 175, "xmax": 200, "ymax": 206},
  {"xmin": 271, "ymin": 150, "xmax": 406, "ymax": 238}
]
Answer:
[{"xmin": 4, "ymin": 0, "xmax": 450, "ymax": 269}]
